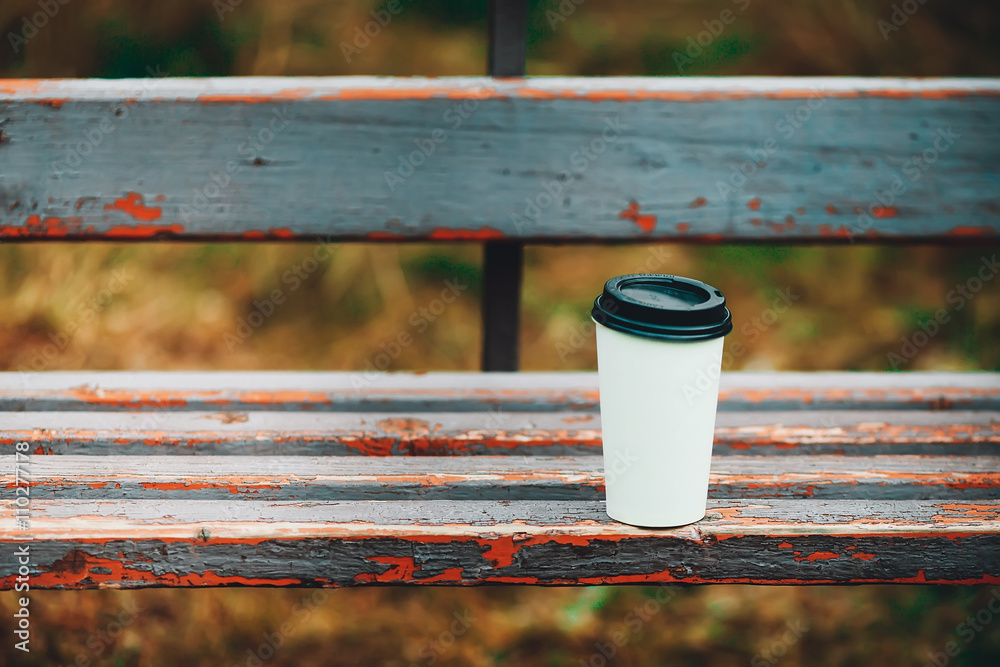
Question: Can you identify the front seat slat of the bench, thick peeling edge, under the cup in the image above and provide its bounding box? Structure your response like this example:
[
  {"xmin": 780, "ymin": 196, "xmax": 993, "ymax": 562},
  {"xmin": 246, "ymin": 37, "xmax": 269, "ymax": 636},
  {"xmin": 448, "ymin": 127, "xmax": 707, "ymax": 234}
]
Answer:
[{"xmin": 0, "ymin": 500, "xmax": 1000, "ymax": 588}]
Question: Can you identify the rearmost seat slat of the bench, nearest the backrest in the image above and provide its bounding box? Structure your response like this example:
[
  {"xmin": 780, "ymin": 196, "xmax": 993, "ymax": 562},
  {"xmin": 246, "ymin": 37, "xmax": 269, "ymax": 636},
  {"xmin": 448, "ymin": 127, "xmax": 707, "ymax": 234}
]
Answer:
[{"xmin": 0, "ymin": 371, "xmax": 1000, "ymax": 412}]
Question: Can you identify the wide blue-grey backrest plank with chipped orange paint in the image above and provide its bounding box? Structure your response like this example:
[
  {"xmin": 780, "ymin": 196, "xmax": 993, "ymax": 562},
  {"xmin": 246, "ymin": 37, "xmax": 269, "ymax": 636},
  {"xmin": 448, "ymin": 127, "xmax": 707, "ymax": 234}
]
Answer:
[{"xmin": 0, "ymin": 77, "xmax": 1000, "ymax": 243}]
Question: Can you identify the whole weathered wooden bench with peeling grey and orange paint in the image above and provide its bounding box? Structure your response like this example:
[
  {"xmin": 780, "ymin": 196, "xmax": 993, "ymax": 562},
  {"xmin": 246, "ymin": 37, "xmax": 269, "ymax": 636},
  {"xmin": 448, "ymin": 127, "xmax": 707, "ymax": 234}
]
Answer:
[{"xmin": 0, "ymin": 2, "xmax": 1000, "ymax": 589}]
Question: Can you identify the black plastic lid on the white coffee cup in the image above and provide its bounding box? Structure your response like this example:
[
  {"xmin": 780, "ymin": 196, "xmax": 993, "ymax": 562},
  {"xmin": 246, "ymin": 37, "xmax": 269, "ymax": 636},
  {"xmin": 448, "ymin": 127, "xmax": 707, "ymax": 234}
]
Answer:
[{"xmin": 590, "ymin": 273, "xmax": 733, "ymax": 342}]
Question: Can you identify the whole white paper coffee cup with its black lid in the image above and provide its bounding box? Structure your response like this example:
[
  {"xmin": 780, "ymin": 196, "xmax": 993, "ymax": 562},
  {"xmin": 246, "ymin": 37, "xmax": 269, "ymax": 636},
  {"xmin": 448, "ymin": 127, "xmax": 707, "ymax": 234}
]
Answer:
[{"xmin": 591, "ymin": 274, "xmax": 732, "ymax": 527}]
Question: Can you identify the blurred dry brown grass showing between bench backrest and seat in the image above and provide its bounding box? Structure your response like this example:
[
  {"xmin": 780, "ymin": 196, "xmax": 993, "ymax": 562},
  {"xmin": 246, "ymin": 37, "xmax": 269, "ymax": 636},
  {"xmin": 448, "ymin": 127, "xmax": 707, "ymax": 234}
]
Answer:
[{"xmin": 0, "ymin": 244, "xmax": 1000, "ymax": 370}]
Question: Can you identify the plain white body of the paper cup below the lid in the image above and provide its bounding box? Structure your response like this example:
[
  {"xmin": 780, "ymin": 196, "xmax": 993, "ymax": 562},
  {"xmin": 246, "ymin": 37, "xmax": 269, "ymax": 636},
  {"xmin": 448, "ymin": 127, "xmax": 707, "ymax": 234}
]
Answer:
[{"xmin": 595, "ymin": 320, "xmax": 724, "ymax": 528}]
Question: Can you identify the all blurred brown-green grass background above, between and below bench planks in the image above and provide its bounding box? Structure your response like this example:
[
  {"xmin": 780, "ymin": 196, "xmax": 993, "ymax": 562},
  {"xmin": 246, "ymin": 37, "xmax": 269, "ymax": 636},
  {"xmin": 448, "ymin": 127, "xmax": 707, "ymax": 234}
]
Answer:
[{"xmin": 0, "ymin": 0, "xmax": 1000, "ymax": 667}]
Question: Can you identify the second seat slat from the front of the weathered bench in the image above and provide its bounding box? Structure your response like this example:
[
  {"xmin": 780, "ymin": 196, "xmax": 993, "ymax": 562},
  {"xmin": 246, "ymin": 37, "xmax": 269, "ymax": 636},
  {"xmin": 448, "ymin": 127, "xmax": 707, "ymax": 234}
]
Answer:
[{"xmin": 0, "ymin": 455, "xmax": 1000, "ymax": 501}]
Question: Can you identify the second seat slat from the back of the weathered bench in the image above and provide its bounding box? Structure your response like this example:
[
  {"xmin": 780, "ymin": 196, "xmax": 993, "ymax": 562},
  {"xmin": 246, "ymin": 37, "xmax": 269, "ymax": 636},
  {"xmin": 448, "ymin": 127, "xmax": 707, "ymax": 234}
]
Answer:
[{"xmin": 0, "ymin": 410, "xmax": 1000, "ymax": 456}]
